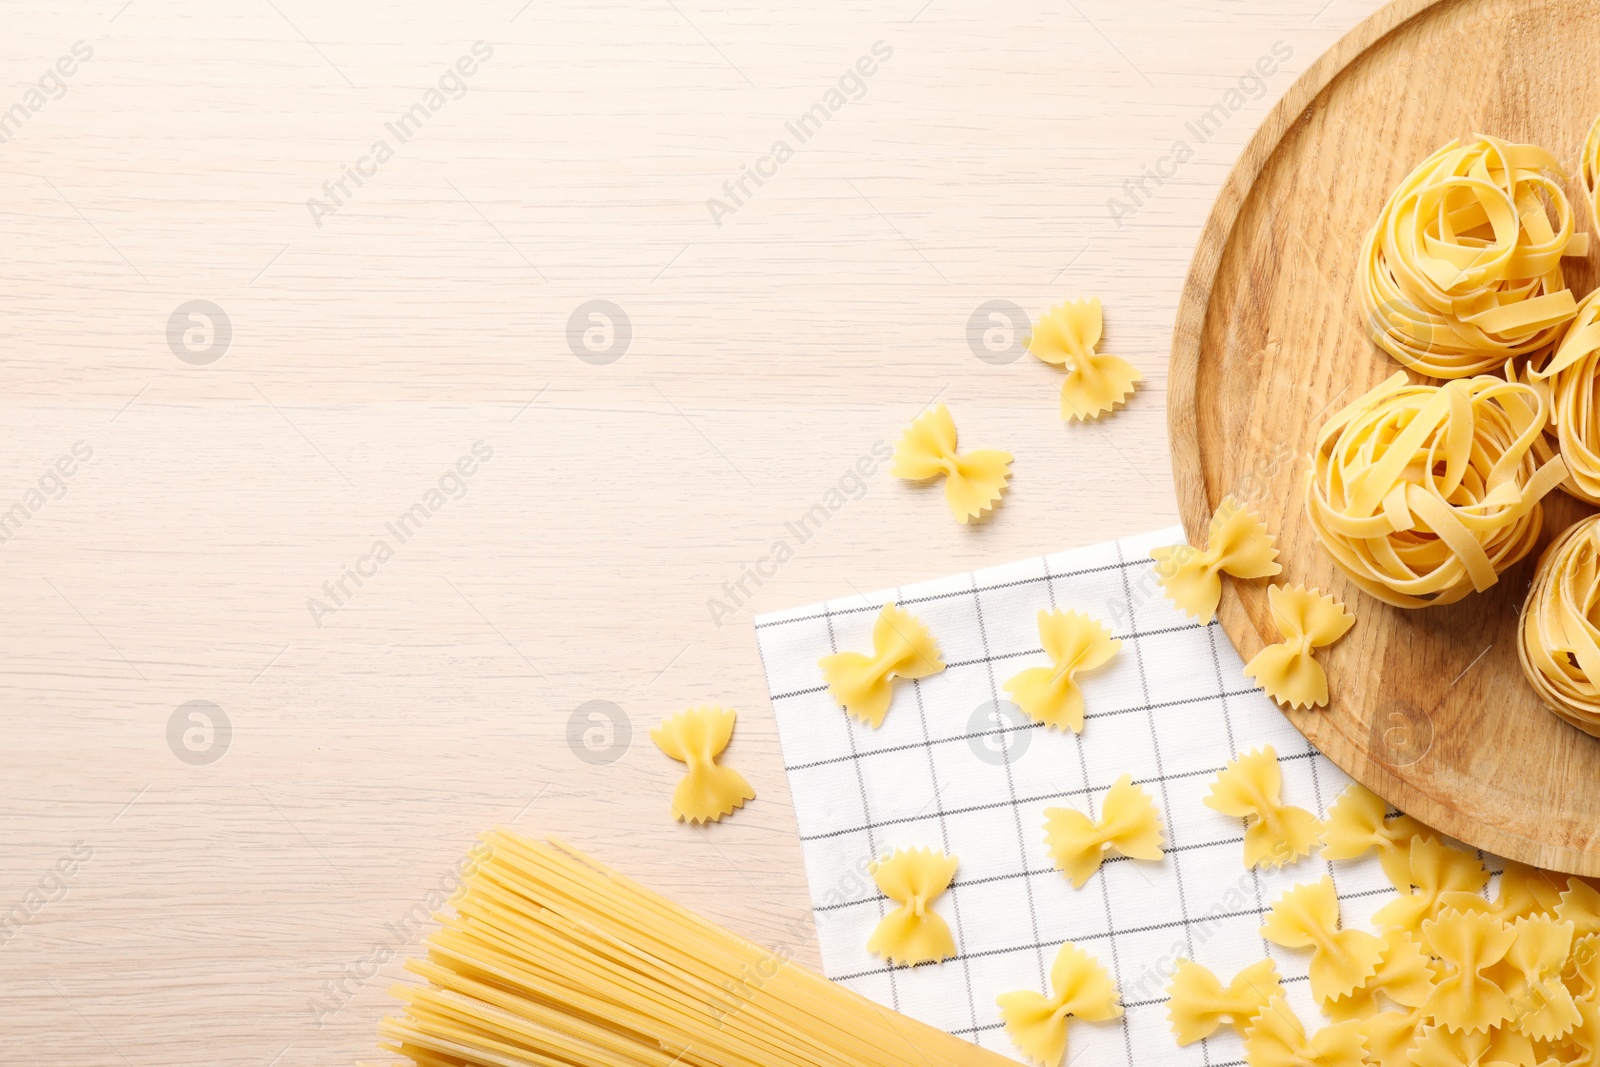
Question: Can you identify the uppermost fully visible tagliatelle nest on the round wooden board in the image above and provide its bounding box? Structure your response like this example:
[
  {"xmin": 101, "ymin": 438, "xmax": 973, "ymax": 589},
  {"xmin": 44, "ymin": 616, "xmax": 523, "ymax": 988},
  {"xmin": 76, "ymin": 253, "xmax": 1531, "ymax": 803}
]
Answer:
[{"xmin": 1358, "ymin": 136, "xmax": 1589, "ymax": 379}]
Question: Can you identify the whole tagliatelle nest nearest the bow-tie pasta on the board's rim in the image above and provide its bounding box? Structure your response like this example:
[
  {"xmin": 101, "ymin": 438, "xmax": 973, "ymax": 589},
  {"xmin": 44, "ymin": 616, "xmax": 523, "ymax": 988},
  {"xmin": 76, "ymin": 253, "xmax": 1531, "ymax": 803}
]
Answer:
[{"xmin": 1306, "ymin": 373, "xmax": 1566, "ymax": 608}]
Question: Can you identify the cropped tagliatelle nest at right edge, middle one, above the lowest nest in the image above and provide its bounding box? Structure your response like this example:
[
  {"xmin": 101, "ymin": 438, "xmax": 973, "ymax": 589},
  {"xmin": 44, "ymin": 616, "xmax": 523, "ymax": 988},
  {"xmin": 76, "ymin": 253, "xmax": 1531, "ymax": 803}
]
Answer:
[{"xmin": 1526, "ymin": 290, "xmax": 1600, "ymax": 504}]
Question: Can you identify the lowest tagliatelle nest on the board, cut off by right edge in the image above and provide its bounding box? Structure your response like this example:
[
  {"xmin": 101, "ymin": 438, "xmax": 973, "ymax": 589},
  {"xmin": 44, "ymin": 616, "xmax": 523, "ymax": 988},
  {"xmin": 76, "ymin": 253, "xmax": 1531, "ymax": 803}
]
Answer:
[{"xmin": 1517, "ymin": 515, "xmax": 1600, "ymax": 737}]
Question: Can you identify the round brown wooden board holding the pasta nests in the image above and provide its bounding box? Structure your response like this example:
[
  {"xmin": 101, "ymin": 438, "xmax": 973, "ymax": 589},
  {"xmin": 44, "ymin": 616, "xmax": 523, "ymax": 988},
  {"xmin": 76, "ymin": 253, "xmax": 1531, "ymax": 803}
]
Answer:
[{"xmin": 1168, "ymin": 0, "xmax": 1600, "ymax": 875}]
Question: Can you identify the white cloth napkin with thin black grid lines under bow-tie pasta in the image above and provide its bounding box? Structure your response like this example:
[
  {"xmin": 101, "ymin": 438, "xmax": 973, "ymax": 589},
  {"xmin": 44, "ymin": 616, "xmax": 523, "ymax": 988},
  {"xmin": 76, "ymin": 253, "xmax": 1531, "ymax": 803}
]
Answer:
[{"xmin": 755, "ymin": 528, "xmax": 1498, "ymax": 1067}]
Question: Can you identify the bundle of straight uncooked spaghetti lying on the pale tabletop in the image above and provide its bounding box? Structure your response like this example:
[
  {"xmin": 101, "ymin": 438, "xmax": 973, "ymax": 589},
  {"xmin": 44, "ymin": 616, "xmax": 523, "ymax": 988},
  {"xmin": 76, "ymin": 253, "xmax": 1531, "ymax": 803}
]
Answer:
[{"xmin": 379, "ymin": 830, "xmax": 1011, "ymax": 1067}]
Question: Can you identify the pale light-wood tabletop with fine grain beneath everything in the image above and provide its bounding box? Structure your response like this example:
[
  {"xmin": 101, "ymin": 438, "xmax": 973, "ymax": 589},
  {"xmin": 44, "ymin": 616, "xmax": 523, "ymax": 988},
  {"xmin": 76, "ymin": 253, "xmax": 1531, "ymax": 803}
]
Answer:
[{"xmin": 0, "ymin": 0, "xmax": 1378, "ymax": 1067}]
